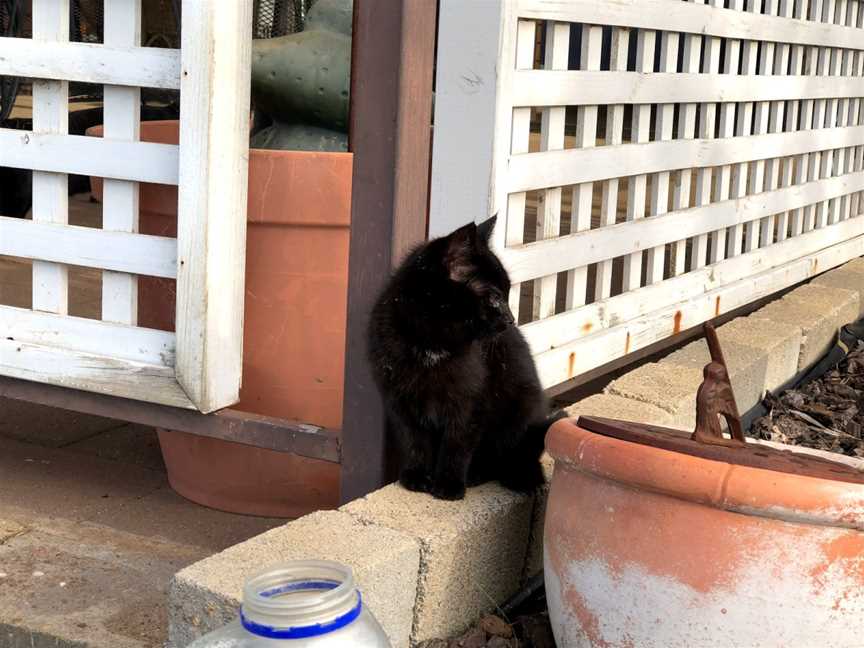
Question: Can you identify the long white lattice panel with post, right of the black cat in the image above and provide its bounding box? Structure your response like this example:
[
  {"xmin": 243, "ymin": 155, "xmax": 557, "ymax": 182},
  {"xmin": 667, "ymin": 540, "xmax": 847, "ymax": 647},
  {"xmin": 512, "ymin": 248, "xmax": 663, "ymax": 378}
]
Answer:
[{"xmin": 430, "ymin": 0, "xmax": 864, "ymax": 386}]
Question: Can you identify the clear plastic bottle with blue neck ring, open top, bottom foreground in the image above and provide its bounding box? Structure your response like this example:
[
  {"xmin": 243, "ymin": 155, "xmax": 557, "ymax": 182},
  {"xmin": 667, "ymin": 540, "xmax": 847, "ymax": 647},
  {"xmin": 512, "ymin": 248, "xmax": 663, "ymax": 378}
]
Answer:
[{"xmin": 188, "ymin": 560, "xmax": 391, "ymax": 648}]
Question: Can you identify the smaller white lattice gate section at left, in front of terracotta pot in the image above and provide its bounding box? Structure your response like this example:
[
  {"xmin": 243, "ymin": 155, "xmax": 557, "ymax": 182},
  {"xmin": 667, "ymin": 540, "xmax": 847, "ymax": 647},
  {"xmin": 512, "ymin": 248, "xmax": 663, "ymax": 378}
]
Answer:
[{"xmin": 0, "ymin": 0, "xmax": 252, "ymax": 412}]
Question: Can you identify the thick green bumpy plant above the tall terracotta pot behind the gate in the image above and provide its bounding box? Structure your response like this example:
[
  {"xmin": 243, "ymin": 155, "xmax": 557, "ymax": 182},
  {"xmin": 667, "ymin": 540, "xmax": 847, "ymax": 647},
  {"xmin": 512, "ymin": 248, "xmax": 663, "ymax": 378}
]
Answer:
[{"xmin": 251, "ymin": 0, "xmax": 353, "ymax": 151}]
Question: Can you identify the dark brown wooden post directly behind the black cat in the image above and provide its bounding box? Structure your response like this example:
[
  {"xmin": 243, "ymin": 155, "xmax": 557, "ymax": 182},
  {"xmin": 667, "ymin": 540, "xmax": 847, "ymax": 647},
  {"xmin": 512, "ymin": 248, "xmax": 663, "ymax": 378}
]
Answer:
[{"xmin": 342, "ymin": 0, "xmax": 437, "ymax": 502}]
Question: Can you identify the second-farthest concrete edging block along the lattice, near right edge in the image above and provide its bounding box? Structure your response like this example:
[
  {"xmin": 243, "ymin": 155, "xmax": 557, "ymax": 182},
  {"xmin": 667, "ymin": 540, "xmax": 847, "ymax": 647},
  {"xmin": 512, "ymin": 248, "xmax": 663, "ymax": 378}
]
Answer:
[{"xmin": 758, "ymin": 284, "xmax": 859, "ymax": 371}]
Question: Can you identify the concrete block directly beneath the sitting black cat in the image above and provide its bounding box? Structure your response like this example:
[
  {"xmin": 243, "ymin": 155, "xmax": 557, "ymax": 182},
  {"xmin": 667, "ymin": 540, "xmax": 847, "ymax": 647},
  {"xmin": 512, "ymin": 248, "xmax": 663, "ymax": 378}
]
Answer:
[{"xmin": 341, "ymin": 483, "xmax": 534, "ymax": 642}]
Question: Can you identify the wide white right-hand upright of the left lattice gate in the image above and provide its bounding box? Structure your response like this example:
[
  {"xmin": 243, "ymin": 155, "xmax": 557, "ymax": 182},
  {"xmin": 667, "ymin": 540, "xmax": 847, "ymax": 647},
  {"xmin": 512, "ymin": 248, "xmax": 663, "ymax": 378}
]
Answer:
[{"xmin": 176, "ymin": 0, "xmax": 252, "ymax": 412}]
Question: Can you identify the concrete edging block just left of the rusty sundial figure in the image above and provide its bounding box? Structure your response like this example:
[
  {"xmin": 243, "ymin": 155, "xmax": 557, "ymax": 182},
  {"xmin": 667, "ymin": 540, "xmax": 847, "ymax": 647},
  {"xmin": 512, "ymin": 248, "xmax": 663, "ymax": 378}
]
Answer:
[{"xmin": 606, "ymin": 362, "xmax": 702, "ymax": 430}]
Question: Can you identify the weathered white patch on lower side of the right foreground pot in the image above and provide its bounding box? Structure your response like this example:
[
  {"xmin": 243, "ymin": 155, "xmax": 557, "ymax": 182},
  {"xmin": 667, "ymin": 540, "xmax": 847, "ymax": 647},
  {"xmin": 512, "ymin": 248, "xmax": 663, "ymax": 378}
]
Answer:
[{"xmin": 545, "ymin": 548, "xmax": 864, "ymax": 648}]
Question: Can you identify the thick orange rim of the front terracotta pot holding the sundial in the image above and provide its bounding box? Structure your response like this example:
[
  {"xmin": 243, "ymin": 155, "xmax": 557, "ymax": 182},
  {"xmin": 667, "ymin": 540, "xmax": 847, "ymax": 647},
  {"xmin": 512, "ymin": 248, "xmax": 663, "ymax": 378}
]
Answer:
[{"xmin": 546, "ymin": 419, "xmax": 864, "ymax": 530}]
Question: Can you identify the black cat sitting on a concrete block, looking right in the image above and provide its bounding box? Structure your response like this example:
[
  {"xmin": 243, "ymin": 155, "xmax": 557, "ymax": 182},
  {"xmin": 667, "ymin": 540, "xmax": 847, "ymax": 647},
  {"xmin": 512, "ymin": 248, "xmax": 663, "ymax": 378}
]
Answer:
[{"xmin": 369, "ymin": 216, "xmax": 551, "ymax": 499}]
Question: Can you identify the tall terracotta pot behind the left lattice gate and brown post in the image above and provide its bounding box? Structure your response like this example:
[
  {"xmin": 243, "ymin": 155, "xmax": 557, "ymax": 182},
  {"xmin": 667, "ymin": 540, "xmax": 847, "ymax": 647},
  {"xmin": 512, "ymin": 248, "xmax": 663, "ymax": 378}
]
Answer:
[{"xmin": 88, "ymin": 121, "xmax": 352, "ymax": 517}]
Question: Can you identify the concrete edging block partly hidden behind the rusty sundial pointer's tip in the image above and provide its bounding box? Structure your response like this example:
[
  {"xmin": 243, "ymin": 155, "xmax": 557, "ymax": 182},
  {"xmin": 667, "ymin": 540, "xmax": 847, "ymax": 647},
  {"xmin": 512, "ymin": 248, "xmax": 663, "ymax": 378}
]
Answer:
[{"xmin": 660, "ymin": 332, "xmax": 768, "ymax": 416}]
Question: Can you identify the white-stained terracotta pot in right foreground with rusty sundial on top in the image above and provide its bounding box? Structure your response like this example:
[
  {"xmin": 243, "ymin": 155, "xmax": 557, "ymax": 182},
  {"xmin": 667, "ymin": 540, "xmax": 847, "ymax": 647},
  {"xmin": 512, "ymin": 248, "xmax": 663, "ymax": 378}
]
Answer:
[{"xmin": 544, "ymin": 421, "xmax": 864, "ymax": 648}]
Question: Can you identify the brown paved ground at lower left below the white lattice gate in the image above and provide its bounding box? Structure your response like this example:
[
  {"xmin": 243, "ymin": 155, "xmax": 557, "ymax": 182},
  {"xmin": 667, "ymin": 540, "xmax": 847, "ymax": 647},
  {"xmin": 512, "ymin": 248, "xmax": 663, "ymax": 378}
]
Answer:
[{"xmin": 0, "ymin": 412, "xmax": 281, "ymax": 648}]
